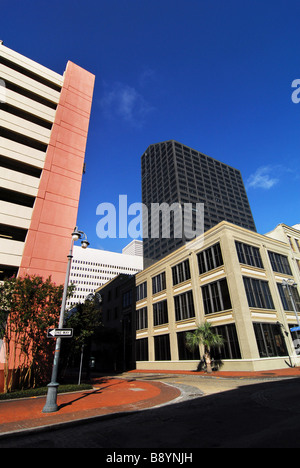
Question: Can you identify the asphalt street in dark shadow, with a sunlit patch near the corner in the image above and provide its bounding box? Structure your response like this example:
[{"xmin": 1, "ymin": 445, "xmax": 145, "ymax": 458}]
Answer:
[{"xmin": 0, "ymin": 376, "xmax": 300, "ymax": 450}]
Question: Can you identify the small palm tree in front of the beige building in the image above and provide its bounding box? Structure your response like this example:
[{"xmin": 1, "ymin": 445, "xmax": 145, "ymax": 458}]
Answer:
[{"xmin": 186, "ymin": 322, "xmax": 224, "ymax": 373}]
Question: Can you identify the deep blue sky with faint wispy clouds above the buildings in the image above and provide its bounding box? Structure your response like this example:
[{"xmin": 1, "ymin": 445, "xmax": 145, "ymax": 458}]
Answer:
[{"xmin": 0, "ymin": 0, "xmax": 300, "ymax": 251}]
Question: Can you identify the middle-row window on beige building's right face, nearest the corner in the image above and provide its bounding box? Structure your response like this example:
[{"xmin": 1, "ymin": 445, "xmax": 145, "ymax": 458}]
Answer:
[{"xmin": 243, "ymin": 277, "xmax": 275, "ymax": 309}]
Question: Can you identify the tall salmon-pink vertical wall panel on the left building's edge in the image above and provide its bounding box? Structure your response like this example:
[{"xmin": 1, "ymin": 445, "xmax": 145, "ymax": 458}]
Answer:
[{"xmin": 19, "ymin": 62, "xmax": 95, "ymax": 284}]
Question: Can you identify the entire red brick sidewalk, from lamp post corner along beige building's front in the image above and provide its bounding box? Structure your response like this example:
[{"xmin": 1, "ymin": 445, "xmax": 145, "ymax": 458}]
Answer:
[{"xmin": 0, "ymin": 367, "xmax": 300, "ymax": 437}]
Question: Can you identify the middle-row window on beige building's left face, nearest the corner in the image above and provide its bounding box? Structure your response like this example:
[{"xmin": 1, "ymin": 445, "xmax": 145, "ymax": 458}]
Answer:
[{"xmin": 202, "ymin": 278, "xmax": 232, "ymax": 315}]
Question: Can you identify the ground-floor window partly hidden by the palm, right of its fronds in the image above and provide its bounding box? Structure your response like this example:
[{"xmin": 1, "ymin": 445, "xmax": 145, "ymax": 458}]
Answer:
[{"xmin": 211, "ymin": 323, "xmax": 241, "ymax": 360}]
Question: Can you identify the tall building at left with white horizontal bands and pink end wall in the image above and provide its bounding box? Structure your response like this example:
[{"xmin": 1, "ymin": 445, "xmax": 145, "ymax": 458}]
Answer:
[{"xmin": 0, "ymin": 42, "xmax": 95, "ymax": 284}]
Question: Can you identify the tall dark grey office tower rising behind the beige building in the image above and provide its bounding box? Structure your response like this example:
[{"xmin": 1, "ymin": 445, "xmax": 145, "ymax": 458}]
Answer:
[{"xmin": 141, "ymin": 140, "xmax": 256, "ymax": 268}]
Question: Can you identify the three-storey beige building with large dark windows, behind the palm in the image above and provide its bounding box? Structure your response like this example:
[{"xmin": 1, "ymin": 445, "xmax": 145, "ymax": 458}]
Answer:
[{"xmin": 136, "ymin": 221, "xmax": 300, "ymax": 371}]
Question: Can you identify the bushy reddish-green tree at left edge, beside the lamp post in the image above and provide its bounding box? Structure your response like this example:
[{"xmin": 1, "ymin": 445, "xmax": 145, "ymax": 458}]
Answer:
[{"xmin": 0, "ymin": 275, "xmax": 67, "ymax": 392}]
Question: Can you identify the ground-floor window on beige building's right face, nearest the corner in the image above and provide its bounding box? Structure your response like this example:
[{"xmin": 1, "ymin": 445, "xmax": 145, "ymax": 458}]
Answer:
[{"xmin": 253, "ymin": 323, "xmax": 288, "ymax": 358}]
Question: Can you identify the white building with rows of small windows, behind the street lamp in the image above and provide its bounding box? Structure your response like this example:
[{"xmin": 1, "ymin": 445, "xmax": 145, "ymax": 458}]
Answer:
[{"xmin": 67, "ymin": 244, "xmax": 143, "ymax": 308}]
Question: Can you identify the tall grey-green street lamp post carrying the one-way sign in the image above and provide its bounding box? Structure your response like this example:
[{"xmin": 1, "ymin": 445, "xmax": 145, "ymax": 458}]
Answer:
[{"xmin": 43, "ymin": 226, "xmax": 89, "ymax": 413}]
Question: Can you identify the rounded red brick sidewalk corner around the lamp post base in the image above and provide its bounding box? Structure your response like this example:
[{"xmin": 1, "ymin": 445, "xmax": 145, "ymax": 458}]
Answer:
[{"xmin": 0, "ymin": 378, "xmax": 181, "ymax": 436}]
